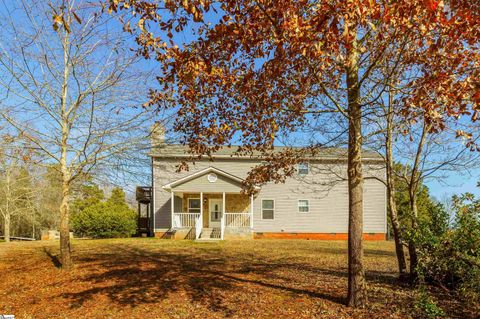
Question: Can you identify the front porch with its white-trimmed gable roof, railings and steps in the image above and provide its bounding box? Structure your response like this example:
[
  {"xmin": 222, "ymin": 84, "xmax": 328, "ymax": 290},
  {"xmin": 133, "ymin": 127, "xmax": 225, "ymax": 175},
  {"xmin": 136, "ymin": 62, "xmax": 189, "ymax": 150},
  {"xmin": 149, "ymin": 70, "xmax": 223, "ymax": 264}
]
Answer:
[{"xmin": 162, "ymin": 167, "xmax": 253, "ymax": 240}]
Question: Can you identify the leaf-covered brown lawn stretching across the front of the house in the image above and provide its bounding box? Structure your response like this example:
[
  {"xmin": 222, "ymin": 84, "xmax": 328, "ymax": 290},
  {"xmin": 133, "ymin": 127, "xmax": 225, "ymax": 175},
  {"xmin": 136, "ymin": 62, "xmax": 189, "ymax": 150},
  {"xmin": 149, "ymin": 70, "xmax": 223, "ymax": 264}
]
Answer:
[{"xmin": 0, "ymin": 238, "xmax": 479, "ymax": 318}]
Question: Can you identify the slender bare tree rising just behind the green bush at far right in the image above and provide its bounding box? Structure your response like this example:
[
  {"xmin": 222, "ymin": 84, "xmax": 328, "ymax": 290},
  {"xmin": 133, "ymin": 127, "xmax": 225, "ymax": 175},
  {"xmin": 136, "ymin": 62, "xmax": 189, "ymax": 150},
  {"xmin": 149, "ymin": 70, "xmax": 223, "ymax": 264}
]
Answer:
[{"xmin": 395, "ymin": 119, "xmax": 480, "ymax": 279}]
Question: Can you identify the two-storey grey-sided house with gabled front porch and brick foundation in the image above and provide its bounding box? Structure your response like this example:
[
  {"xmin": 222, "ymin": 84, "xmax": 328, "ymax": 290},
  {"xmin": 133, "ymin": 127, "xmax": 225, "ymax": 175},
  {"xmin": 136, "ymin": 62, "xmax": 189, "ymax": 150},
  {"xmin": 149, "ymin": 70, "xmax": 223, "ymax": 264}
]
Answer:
[{"xmin": 141, "ymin": 127, "xmax": 387, "ymax": 240}]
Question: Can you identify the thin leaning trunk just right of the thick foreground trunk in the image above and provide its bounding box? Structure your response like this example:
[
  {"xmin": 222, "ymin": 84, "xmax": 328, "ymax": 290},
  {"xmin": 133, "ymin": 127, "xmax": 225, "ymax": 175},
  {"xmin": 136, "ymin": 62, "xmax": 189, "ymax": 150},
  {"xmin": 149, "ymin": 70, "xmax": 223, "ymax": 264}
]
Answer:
[{"xmin": 385, "ymin": 86, "xmax": 407, "ymax": 279}]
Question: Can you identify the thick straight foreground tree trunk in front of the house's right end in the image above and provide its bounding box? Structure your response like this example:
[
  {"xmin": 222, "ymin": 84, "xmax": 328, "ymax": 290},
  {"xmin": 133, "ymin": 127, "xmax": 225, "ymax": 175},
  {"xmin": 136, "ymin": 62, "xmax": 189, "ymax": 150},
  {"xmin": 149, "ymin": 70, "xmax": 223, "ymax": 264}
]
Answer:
[{"xmin": 346, "ymin": 28, "xmax": 367, "ymax": 307}]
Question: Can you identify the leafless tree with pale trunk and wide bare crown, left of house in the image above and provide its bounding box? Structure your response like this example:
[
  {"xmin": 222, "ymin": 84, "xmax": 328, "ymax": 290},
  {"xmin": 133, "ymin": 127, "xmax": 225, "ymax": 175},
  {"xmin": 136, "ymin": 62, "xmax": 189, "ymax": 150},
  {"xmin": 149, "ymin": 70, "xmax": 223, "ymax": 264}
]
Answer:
[{"xmin": 0, "ymin": 0, "xmax": 152, "ymax": 269}]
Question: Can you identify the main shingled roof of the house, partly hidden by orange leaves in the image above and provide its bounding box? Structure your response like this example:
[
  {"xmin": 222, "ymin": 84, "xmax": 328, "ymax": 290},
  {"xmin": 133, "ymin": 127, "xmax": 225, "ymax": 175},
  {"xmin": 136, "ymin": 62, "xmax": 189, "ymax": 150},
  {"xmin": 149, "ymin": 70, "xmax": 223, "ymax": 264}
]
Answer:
[{"xmin": 149, "ymin": 144, "xmax": 384, "ymax": 161}]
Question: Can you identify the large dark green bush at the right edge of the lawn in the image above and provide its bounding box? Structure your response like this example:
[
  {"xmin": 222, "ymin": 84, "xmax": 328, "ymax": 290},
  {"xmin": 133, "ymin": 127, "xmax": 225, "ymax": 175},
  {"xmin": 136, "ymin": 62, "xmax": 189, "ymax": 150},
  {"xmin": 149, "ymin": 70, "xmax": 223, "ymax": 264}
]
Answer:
[{"xmin": 414, "ymin": 194, "xmax": 480, "ymax": 303}]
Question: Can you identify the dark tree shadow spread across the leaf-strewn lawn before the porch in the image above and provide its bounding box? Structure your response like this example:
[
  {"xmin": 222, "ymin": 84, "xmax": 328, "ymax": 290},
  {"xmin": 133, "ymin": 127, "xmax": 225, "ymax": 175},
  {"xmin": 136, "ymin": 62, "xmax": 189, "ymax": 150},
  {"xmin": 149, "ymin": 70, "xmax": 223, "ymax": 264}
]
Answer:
[{"xmin": 55, "ymin": 245, "xmax": 402, "ymax": 317}]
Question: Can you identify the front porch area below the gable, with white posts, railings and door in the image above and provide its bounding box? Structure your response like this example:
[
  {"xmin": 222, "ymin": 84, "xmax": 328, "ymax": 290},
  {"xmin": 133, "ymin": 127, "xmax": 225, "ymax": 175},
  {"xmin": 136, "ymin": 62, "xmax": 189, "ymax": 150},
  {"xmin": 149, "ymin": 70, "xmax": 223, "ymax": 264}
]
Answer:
[{"xmin": 171, "ymin": 190, "xmax": 253, "ymax": 240}]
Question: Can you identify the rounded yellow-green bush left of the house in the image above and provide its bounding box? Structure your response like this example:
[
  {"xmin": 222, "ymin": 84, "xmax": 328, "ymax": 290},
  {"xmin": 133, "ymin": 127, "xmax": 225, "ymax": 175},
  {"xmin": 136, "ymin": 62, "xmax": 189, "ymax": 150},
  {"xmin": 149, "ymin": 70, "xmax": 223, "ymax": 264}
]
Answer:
[{"xmin": 72, "ymin": 201, "xmax": 137, "ymax": 238}]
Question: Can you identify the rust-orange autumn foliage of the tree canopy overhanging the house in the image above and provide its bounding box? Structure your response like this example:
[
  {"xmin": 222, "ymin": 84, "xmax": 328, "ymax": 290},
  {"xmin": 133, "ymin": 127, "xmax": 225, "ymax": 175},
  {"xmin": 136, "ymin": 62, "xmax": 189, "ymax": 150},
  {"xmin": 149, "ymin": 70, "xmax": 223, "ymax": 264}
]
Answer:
[{"xmin": 110, "ymin": 0, "xmax": 480, "ymax": 159}]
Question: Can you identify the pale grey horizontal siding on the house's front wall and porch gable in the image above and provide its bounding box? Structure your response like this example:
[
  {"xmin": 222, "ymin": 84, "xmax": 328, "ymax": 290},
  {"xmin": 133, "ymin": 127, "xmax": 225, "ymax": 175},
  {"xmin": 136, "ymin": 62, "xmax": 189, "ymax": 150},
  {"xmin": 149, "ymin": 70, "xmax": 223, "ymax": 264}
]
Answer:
[{"xmin": 153, "ymin": 158, "xmax": 386, "ymax": 233}]
